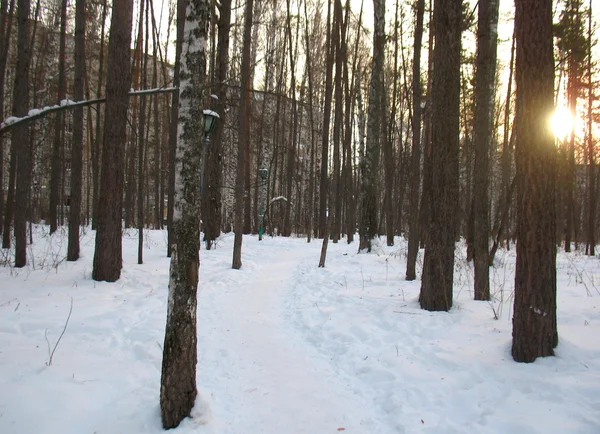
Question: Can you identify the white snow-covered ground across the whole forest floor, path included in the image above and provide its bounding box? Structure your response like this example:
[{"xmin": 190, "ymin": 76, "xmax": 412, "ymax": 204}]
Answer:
[{"xmin": 0, "ymin": 227, "xmax": 600, "ymax": 434}]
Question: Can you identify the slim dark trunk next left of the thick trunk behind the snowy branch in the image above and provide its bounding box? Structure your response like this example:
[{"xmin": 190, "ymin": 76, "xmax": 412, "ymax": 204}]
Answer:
[{"xmin": 67, "ymin": 0, "xmax": 86, "ymax": 261}]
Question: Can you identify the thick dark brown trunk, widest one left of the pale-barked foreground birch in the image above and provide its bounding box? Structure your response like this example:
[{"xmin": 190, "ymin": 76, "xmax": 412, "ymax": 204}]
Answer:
[{"xmin": 92, "ymin": 0, "xmax": 133, "ymax": 282}]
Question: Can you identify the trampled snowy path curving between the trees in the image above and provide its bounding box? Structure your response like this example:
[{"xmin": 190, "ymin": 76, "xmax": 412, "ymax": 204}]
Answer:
[{"xmin": 198, "ymin": 240, "xmax": 387, "ymax": 434}]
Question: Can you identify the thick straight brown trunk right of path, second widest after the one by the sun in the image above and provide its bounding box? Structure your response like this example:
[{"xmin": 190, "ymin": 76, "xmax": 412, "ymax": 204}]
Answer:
[{"xmin": 419, "ymin": 0, "xmax": 462, "ymax": 311}]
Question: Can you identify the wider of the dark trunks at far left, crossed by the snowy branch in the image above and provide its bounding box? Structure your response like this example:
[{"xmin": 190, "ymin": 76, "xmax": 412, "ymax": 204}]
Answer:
[{"xmin": 11, "ymin": 0, "xmax": 32, "ymax": 268}]
